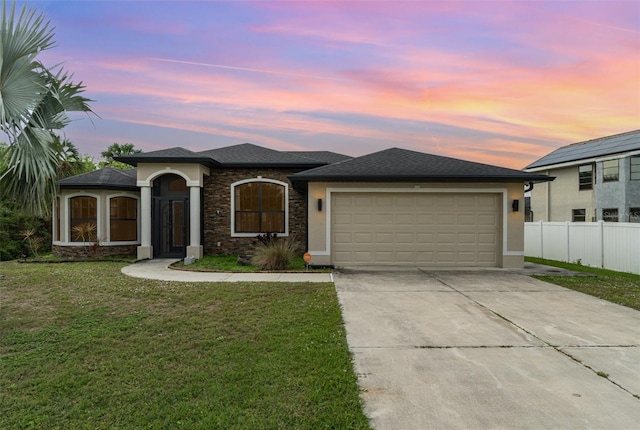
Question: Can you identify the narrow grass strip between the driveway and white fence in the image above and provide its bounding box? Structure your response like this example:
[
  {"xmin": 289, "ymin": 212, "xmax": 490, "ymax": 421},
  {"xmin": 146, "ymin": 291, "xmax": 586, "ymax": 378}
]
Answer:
[{"xmin": 526, "ymin": 257, "xmax": 640, "ymax": 310}]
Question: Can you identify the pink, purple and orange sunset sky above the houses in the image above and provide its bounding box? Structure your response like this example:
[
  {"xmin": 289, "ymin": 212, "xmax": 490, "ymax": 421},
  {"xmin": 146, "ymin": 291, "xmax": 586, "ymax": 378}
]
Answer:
[{"xmin": 23, "ymin": 1, "xmax": 640, "ymax": 169}]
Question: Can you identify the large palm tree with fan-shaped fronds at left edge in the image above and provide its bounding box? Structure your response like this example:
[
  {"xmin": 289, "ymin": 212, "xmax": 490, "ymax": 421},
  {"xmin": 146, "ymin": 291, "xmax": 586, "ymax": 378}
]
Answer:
[{"xmin": 0, "ymin": 1, "xmax": 92, "ymax": 215}]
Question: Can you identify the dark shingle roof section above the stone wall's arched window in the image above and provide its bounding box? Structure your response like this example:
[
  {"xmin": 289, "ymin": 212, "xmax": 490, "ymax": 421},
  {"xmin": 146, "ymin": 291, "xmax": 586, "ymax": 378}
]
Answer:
[{"xmin": 198, "ymin": 143, "xmax": 326, "ymax": 168}]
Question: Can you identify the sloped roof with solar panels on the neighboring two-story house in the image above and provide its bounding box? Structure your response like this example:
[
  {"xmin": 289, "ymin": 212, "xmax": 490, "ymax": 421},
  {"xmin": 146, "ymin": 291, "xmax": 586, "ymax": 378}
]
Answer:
[{"xmin": 525, "ymin": 130, "xmax": 640, "ymax": 169}]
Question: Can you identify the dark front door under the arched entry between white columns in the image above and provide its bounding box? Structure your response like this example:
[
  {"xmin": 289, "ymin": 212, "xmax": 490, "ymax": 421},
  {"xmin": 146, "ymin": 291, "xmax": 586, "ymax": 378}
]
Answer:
[{"xmin": 153, "ymin": 197, "xmax": 189, "ymax": 258}]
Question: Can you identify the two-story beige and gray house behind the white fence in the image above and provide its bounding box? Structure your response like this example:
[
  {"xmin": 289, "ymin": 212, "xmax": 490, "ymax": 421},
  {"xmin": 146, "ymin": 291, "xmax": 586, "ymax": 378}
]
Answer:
[{"xmin": 524, "ymin": 130, "xmax": 640, "ymax": 222}]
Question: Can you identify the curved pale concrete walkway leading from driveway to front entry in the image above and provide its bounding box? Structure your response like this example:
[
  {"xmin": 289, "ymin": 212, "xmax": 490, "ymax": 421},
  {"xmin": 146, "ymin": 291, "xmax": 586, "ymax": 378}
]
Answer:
[{"xmin": 122, "ymin": 258, "xmax": 333, "ymax": 282}]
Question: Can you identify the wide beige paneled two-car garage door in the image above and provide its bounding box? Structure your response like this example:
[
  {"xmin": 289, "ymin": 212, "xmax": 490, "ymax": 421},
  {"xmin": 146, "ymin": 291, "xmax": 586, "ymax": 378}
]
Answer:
[{"xmin": 331, "ymin": 193, "xmax": 501, "ymax": 266}]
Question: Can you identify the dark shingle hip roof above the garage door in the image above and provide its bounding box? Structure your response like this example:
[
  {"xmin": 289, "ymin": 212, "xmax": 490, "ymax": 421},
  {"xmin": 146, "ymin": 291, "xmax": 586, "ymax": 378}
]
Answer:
[{"xmin": 289, "ymin": 148, "xmax": 550, "ymax": 182}]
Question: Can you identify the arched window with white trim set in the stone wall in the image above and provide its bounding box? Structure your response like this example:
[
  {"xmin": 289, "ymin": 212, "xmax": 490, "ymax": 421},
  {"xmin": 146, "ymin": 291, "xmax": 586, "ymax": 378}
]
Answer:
[{"xmin": 232, "ymin": 180, "xmax": 287, "ymax": 235}]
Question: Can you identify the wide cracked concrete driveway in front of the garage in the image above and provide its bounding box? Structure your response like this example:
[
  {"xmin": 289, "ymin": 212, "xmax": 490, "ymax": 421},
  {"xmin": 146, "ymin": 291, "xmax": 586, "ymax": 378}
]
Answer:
[{"xmin": 334, "ymin": 269, "xmax": 640, "ymax": 430}]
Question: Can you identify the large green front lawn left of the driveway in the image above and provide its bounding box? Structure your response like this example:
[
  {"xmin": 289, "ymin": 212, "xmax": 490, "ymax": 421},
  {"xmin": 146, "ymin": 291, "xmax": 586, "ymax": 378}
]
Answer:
[{"xmin": 0, "ymin": 262, "xmax": 369, "ymax": 429}]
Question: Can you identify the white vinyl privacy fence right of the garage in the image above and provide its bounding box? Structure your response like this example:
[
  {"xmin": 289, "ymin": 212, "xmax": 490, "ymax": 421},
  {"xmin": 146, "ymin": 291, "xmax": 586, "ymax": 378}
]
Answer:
[{"xmin": 524, "ymin": 221, "xmax": 640, "ymax": 274}]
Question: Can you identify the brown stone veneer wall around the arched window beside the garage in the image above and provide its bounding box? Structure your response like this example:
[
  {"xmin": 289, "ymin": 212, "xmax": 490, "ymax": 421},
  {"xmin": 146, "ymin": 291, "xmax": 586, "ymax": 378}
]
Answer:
[{"xmin": 203, "ymin": 169, "xmax": 307, "ymax": 255}]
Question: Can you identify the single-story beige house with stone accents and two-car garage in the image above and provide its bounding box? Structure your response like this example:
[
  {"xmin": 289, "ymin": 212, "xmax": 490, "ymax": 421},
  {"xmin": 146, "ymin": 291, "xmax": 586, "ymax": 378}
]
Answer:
[{"xmin": 53, "ymin": 144, "xmax": 550, "ymax": 267}]
